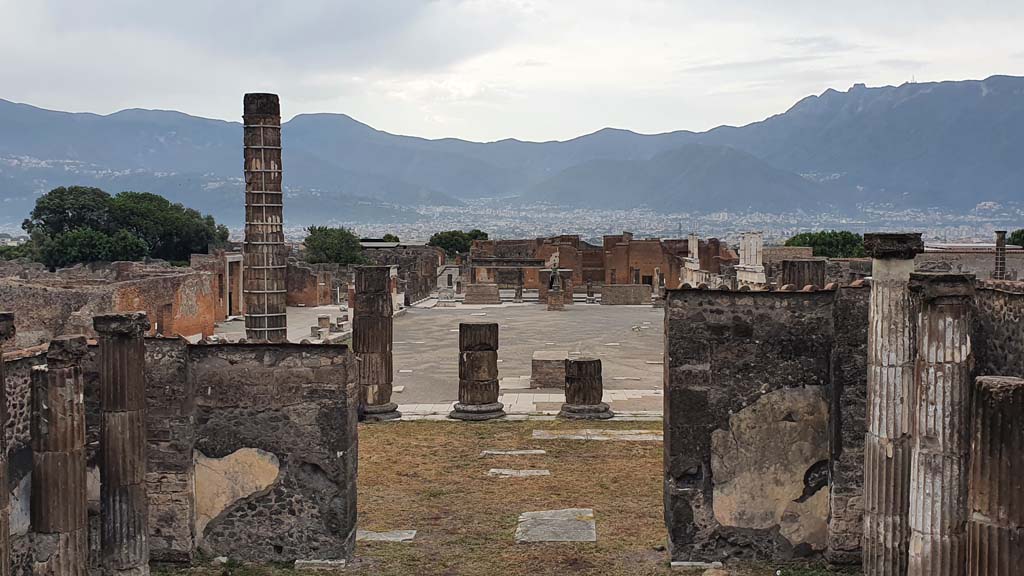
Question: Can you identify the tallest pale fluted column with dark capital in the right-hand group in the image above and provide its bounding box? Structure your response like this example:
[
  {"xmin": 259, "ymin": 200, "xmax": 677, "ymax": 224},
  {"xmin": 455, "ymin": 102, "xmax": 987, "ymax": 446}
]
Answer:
[{"xmin": 863, "ymin": 234, "xmax": 924, "ymax": 576}]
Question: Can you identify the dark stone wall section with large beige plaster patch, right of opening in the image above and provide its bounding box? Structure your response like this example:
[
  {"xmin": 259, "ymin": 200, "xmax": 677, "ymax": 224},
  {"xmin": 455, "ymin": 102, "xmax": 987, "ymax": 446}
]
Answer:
[{"xmin": 665, "ymin": 290, "xmax": 843, "ymax": 561}]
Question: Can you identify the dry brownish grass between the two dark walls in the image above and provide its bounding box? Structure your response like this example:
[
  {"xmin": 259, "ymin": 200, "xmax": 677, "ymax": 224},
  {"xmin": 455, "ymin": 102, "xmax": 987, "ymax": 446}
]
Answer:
[{"xmin": 165, "ymin": 421, "xmax": 856, "ymax": 576}]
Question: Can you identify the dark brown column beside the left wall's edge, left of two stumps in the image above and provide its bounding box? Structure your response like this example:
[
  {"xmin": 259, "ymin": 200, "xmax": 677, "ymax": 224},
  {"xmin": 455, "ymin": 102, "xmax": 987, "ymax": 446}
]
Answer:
[{"xmin": 352, "ymin": 266, "xmax": 401, "ymax": 422}]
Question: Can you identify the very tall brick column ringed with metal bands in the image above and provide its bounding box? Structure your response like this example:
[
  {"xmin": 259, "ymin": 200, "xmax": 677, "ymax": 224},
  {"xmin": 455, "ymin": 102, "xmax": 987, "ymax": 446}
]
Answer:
[{"xmin": 243, "ymin": 90, "xmax": 288, "ymax": 342}]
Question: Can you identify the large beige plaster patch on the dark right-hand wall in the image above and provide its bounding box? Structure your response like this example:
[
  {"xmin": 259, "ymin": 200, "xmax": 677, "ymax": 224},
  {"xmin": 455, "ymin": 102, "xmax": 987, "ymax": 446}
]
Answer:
[{"xmin": 711, "ymin": 386, "xmax": 828, "ymax": 550}]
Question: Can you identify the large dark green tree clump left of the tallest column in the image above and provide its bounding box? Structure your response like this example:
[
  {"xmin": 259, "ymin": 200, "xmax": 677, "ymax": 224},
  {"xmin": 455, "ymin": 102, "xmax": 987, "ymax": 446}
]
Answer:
[{"xmin": 15, "ymin": 187, "xmax": 228, "ymax": 269}]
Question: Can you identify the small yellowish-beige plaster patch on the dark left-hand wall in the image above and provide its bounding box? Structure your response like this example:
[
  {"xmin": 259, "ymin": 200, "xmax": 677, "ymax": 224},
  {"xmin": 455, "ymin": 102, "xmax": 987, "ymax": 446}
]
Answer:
[{"xmin": 196, "ymin": 448, "xmax": 281, "ymax": 543}]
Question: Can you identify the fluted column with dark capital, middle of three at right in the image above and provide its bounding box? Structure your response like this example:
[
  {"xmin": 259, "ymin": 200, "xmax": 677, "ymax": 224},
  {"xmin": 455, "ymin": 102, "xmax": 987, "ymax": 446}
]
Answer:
[{"xmin": 907, "ymin": 273, "xmax": 974, "ymax": 576}]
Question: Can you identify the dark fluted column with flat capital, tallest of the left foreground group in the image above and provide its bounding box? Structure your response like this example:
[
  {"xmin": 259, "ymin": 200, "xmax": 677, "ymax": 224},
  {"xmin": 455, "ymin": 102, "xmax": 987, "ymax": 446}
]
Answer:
[{"xmin": 93, "ymin": 312, "xmax": 150, "ymax": 576}]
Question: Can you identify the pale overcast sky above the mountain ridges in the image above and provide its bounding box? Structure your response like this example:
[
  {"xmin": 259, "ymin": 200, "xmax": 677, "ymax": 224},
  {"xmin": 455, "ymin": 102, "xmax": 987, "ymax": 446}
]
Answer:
[{"xmin": 0, "ymin": 0, "xmax": 1024, "ymax": 140}]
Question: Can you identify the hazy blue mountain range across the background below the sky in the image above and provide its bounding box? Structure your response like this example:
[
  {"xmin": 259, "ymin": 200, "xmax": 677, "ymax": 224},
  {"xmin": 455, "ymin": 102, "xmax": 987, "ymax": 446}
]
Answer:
[{"xmin": 0, "ymin": 76, "xmax": 1024, "ymax": 224}]
